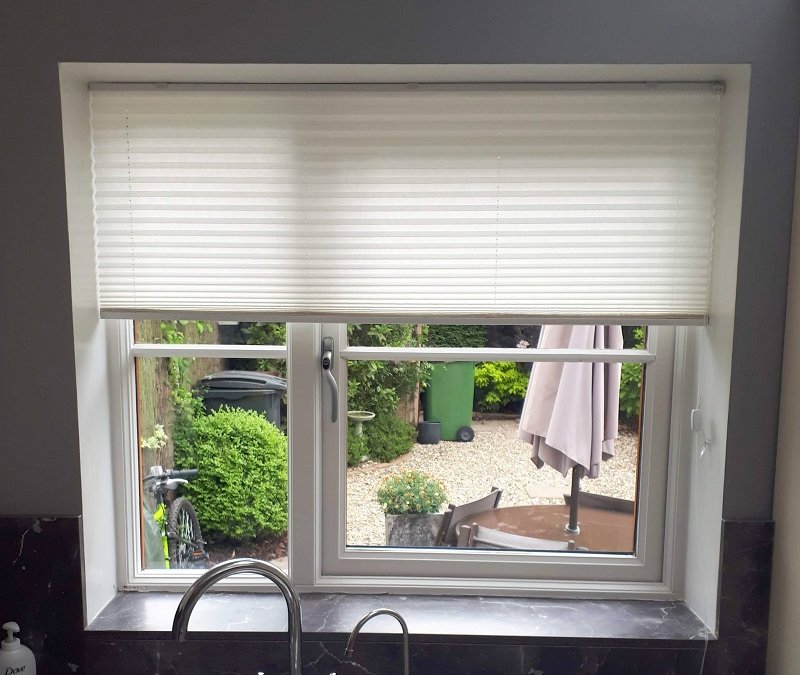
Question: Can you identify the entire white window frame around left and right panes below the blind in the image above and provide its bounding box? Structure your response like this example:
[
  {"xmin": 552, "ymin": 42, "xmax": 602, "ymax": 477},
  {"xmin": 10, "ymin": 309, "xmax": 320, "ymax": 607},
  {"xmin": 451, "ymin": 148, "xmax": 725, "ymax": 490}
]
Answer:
[{"xmin": 114, "ymin": 321, "xmax": 680, "ymax": 595}]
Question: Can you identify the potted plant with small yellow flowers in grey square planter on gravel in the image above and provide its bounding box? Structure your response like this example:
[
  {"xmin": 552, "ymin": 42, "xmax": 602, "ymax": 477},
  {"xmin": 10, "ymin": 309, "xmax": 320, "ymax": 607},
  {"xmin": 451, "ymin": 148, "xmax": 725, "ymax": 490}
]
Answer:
[{"xmin": 378, "ymin": 471, "xmax": 447, "ymax": 546}]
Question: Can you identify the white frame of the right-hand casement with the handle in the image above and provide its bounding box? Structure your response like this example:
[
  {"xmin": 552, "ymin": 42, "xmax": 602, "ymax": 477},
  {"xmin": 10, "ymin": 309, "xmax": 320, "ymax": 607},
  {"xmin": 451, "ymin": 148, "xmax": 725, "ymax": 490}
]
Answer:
[{"xmin": 315, "ymin": 324, "xmax": 678, "ymax": 594}]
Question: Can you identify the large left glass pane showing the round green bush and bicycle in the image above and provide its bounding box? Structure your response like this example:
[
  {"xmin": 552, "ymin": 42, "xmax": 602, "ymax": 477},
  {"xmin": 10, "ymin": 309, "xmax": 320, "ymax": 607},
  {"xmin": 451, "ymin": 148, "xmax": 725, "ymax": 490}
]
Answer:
[{"xmin": 136, "ymin": 357, "xmax": 288, "ymax": 570}]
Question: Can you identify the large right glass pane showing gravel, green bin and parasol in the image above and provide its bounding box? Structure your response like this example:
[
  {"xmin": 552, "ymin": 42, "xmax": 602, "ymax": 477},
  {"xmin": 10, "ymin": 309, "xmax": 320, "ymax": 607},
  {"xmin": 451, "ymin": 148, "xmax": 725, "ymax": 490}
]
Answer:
[{"xmin": 346, "ymin": 354, "xmax": 643, "ymax": 553}]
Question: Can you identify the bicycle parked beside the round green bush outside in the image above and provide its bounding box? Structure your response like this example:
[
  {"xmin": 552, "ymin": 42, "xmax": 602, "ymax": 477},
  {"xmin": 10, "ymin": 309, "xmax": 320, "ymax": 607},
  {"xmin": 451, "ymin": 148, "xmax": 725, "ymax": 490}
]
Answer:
[{"xmin": 143, "ymin": 466, "xmax": 208, "ymax": 569}]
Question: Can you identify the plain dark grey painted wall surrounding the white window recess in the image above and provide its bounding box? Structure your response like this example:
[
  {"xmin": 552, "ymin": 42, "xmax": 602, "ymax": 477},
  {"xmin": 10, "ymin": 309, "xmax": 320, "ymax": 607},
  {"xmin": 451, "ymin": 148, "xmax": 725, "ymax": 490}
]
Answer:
[{"xmin": 0, "ymin": 0, "xmax": 800, "ymax": 518}]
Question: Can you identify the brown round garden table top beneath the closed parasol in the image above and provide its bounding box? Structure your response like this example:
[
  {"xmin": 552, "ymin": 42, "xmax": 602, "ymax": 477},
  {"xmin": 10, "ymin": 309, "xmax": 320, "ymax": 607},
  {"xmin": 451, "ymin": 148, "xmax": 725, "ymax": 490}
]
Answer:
[{"xmin": 459, "ymin": 504, "xmax": 636, "ymax": 553}]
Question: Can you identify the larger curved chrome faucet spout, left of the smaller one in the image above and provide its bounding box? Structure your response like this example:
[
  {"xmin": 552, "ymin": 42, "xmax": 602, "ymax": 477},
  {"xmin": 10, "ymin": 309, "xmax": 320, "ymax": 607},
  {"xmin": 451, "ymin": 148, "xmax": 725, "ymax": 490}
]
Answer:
[{"xmin": 172, "ymin": 558, "xmax": 303, "ymax": 675}]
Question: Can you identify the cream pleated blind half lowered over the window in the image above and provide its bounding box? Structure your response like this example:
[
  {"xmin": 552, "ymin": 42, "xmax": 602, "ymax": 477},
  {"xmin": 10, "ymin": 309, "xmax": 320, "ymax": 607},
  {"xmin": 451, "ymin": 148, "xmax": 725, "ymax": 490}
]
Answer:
[{"xmin": 91, "ymin": 85, "xmax": 721, "ymax": 323}]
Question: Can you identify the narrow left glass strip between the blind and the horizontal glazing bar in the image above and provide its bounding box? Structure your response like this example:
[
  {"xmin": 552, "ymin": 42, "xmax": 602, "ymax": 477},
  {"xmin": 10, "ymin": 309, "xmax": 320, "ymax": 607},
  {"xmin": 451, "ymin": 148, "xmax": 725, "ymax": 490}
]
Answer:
[{"xmin": 133, "ymin": 320, "xmax": 286, "ymax": 345}]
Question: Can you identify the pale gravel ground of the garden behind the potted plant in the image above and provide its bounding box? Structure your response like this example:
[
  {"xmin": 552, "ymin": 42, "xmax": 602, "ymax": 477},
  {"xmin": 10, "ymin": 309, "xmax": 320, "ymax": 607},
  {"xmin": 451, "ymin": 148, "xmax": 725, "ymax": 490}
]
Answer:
[{"xmin": 347, "ymin": 420, "xmax": 638, "ymax": 546}]
